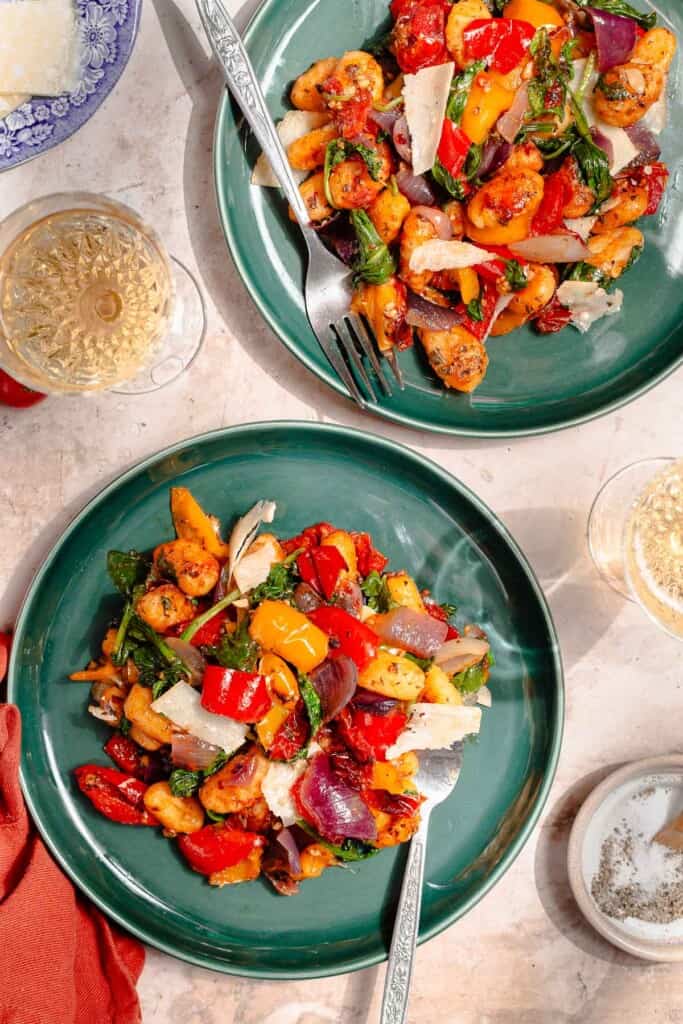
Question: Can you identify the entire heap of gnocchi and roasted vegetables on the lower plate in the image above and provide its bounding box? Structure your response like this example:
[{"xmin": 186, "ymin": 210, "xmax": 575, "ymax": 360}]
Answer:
[{"xmin": 72, "ymin": 493, "xmax": 490, "ymax": 895}]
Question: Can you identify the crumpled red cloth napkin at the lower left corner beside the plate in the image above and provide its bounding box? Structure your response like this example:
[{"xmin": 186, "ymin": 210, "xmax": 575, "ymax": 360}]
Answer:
[{"xmin": 0, "ymin": 705, "xmax": 144, "ymax": 1024}]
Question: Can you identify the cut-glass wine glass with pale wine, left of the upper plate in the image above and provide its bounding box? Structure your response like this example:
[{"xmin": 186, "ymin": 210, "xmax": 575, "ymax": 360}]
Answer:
[{"xmin": 0, "ymin": 191, "xmax": 206, "ymax": 394}]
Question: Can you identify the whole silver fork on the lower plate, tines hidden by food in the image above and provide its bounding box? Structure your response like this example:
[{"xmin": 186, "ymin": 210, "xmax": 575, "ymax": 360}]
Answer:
[{"xmin": 380, "ymin": 742, "xmax": 463, "ymax": 1024}]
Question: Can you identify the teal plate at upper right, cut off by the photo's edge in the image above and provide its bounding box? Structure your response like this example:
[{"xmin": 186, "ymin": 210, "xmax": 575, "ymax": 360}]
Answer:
[{"xmin": 214, "ymin": 0, "xmax": 683, "ymax": 437}]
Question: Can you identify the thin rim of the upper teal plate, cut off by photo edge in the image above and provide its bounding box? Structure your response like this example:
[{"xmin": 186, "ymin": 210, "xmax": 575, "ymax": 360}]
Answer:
[{"xmin": 211, "ymin": 0, "xmax": 683, "ymax": 438}]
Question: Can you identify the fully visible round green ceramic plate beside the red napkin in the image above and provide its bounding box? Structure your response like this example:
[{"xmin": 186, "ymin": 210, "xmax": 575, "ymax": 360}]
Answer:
[{"xmin": 9, "ymin": 423, "xmax": 563, "ymax": 978}]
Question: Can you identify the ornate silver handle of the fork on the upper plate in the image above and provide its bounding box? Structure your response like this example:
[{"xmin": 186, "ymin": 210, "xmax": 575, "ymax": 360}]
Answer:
[{"xmin": 197, "ymin": 0, "xmax": 310, "ymax": 228}]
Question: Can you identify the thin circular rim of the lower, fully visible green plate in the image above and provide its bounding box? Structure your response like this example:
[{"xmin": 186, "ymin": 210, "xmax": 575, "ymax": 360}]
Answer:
[{"xmin": 7, "ymin": 420, "xmax": 565, "ymax": 981}]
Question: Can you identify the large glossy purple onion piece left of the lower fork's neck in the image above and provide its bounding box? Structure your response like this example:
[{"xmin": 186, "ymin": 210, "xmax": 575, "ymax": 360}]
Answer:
[{"xmin": 298, "ymin": 754, "xmax": 377, "ymax": 842}]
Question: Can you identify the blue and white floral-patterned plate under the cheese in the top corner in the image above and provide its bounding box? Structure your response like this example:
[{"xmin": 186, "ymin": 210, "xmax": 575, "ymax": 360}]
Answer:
[{"xmin": 0, "ymin": 0, "xmax": 142, "ymax": 171}]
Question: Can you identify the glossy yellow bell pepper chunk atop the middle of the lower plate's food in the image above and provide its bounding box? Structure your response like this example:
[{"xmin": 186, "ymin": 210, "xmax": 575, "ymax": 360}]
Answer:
[{"xmin": 249, "ymin": 601, "xmax": 329, "ymax": 672}]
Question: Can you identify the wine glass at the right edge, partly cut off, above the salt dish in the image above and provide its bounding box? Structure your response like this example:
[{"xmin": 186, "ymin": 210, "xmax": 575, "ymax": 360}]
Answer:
[{"xmin": 588, "ymin": 458, "xmax": 683, "ymax": 640}]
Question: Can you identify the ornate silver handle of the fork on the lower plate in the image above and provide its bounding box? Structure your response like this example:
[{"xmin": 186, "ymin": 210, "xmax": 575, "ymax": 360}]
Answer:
[{"xmin": 380, "ymin": 810, "xmax": 429, "ymax": 1024}]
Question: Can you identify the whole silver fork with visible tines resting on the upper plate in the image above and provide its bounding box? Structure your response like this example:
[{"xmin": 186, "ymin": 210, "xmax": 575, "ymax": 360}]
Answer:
[{"xmin": 197, "ymin": 0, "xmax": 403, "ymax": 408}]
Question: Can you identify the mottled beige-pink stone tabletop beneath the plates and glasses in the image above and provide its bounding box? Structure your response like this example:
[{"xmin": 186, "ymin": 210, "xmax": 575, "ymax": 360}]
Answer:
[{"xmin": 0, "ymin": 0, "xmax": 683, "ymax": 1024}]
